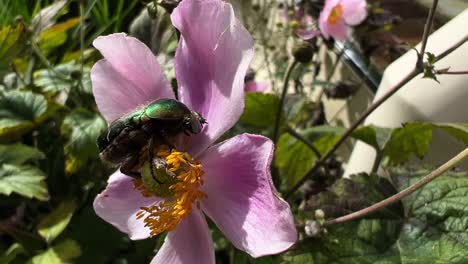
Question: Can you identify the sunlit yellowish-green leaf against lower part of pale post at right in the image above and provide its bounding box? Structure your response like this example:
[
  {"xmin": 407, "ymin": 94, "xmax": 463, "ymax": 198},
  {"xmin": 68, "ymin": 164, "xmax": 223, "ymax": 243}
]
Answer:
[{"xmin": 383, "ymin": 123, "xmax": 432, "ymax": 164}]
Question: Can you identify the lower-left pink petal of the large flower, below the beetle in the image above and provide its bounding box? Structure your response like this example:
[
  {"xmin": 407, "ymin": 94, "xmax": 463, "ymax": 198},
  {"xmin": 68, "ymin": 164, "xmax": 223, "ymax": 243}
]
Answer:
[{"xmin": 93, "ymin": 171, "xmax": 158, "ymax": 240}]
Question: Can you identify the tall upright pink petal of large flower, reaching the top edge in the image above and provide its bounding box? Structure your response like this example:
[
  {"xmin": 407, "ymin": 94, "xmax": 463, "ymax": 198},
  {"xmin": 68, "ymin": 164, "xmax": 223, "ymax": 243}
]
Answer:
[{"xmin": 171, "ymin": 0, "xmax": 253, "ymax": 156}]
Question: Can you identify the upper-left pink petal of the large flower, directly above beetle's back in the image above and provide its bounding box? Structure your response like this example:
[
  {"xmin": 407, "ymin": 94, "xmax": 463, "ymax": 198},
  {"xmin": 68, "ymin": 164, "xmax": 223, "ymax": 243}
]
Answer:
[{"xmin": 91, "ymin": 33, "xmax": 174, "ymax": 122}]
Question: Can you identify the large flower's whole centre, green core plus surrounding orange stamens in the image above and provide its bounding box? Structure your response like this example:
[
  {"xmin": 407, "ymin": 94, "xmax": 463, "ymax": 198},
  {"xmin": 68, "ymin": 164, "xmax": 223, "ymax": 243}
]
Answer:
[{"xmin": 134, "ymin": 145, "xmax": 206, "ymax": 236}]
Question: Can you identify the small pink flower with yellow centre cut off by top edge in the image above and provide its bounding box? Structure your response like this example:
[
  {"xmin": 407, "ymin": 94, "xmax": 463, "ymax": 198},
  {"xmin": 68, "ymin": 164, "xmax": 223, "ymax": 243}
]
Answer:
[{"xmin": 319, "ymin": 0, "xmax": 367, "ymax": 41}]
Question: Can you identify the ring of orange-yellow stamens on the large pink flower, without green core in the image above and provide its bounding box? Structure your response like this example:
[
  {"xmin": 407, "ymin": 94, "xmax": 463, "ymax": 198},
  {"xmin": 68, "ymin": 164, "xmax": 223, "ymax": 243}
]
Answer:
[{"xmin": 134, "ymin": 145, "xmax": 207, "ymax": 236}]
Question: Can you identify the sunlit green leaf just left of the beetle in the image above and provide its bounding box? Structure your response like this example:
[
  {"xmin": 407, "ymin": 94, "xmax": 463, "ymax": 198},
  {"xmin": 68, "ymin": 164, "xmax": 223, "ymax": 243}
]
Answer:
[{"xmin": 61, "ymin": 109, "xmax": 107, "ymax": 159}]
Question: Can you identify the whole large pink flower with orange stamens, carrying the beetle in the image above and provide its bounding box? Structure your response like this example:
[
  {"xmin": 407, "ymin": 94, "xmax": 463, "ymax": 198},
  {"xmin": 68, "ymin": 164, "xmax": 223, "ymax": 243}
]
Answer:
[{"xmin": 91, "ymin": 0, "xmax": 297, "ymax": 263}]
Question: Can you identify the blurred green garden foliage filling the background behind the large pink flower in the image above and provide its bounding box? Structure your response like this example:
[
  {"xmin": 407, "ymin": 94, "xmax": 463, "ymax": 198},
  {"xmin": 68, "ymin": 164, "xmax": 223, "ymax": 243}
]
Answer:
[{"xmin": 0, "ymin": 0, "xmax": 468, "ymax": 264}]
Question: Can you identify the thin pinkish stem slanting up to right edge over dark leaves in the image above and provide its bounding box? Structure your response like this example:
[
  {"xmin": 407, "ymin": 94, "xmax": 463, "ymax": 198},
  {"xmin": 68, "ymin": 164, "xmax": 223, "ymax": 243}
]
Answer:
[{"xmin": 324, "ymin": 148, "xmax": 468, "ymax": 225}]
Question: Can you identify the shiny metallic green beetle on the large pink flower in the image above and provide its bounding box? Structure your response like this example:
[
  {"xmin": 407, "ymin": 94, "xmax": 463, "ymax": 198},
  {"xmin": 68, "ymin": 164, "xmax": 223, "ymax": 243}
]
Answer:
[{"xmin": 97, "ymin": 99, "xmax": 206, "ymax": 176}]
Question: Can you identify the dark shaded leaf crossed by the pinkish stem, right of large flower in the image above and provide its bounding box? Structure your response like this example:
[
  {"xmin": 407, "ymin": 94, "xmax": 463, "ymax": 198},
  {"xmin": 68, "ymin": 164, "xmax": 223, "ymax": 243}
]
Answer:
[{"xmin": 284, "ymin": 174, "xmax": 404, "ymax": 264}]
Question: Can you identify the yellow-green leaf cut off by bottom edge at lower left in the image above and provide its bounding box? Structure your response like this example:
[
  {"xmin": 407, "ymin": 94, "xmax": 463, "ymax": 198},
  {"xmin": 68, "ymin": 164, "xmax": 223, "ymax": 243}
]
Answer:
[{"xmin": 27, "ymin": 239, "xmax": 81, "ymax": 264}]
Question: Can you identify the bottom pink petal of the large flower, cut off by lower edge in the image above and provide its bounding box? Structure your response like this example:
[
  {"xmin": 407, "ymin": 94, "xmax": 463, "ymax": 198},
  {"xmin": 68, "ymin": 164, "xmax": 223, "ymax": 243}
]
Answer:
[{"xmin": 151, "ymin": 208, "xmax": 215, "ymax": 264}]
